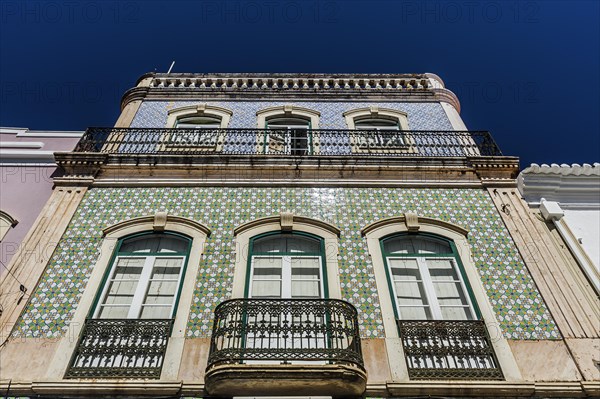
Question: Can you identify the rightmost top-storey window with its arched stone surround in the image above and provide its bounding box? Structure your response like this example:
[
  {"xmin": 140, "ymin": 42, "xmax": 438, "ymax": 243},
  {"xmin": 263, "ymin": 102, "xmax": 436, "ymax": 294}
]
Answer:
[{"xmin": 344, "ymin": 106, "xmax": 410, "ymax": 153}]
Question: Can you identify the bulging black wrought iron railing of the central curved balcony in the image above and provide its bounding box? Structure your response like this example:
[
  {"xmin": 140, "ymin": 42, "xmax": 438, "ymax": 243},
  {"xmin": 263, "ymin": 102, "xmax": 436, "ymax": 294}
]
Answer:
[{"xmin": 208, "ymin": 299, "xmax": 363, "ymax": 369}]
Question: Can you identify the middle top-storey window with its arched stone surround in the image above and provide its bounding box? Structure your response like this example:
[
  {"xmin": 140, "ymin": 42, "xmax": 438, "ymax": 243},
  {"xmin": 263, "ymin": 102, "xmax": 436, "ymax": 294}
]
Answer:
[{"xmin": 256, "ymin": 105, "xmax": 320, "ymax": 156}]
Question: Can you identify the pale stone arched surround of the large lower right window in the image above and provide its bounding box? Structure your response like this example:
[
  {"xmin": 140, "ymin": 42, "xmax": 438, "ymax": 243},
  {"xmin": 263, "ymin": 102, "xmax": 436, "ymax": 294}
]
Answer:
[{"xmin": 361, "ymin": 213, "xmax": 522, "ymax": 381}]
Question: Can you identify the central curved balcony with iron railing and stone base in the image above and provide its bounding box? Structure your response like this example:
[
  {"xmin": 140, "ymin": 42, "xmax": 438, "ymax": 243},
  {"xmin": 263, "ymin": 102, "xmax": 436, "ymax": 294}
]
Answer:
[{"xmin": 205, "ymin": 299, "xmax": 367, "ymax": 397}]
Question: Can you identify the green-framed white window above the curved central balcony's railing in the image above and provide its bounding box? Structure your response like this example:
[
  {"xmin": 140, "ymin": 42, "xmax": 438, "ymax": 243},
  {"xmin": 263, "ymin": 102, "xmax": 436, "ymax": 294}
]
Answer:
[{"xmin": 245, "ymin": 232, "xmax": 328, "ymax": 298}]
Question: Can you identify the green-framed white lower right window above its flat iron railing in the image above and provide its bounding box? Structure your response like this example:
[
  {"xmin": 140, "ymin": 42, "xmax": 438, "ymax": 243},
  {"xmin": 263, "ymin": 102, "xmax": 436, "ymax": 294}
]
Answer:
[{"xmin": 381, "ymin": 233, "xmax": 481, "ymax": 320}]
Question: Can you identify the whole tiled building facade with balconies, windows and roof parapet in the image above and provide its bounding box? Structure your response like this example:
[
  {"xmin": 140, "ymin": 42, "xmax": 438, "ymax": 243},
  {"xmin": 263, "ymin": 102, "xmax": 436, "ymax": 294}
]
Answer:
[{"xmin": 0, "ymin": 74, "xmax": 600, "ymax": 397}]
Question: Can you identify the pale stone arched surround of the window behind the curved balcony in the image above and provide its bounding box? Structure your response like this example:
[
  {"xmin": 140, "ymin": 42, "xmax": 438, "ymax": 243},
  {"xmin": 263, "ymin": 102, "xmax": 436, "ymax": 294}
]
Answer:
[{"xmin": 232, "ymin": 213, "xmax": 342, "ymax": 299}]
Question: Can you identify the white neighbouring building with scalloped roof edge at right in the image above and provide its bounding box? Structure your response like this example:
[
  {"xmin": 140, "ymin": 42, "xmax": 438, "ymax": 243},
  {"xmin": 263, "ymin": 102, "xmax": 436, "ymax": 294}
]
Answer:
[{"xmin": 517, "ymin": 163, "xmax": 600, "ymax": 293}]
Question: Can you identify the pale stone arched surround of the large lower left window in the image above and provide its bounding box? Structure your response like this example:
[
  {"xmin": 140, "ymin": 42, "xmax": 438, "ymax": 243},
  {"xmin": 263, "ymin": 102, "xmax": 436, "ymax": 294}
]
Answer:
[{"xmin": 46, "ymin": 212, "xmax": 210, "ymax": 381}]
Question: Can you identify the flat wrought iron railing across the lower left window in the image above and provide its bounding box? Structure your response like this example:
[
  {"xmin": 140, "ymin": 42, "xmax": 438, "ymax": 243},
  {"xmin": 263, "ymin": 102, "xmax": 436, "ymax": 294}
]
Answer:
[{"xmin": 65, "ymin": 319, "xmax": 173, "ymax": 379}]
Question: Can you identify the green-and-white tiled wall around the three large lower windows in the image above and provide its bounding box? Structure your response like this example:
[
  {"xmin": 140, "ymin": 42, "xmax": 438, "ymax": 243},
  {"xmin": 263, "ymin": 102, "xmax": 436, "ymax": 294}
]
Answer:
[{"xmin": 14, "ymin": 187, "xmax": 560, "ymax": 339}]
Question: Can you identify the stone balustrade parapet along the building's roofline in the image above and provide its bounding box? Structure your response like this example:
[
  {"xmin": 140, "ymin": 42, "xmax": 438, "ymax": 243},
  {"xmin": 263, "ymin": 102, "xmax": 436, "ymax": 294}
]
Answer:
[{"xmin": 121, "ymin": 73, "xmax": 460, "ymax": 112}]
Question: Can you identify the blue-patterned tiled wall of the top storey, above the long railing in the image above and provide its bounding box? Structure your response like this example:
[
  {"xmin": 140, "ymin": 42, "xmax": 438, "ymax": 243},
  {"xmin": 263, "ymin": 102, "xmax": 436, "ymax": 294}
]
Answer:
[{"xmin": 131, "ymin": 101, "xmax": 452, "ymax": 130}]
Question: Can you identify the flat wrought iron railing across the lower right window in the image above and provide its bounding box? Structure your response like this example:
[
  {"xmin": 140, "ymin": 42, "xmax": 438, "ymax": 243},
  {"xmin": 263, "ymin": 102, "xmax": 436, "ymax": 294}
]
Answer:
[{"xmin": 398, "ymin": 320, "xmax": 504, "ymax": 380}]
